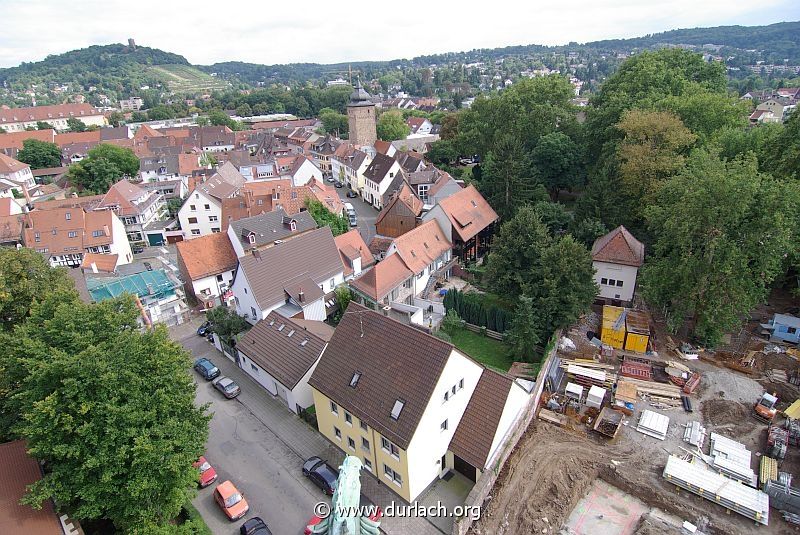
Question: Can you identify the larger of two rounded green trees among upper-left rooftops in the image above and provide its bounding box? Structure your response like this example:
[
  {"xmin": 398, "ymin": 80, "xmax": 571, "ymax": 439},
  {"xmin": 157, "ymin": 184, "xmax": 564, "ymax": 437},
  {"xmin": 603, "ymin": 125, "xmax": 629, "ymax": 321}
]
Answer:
[{"xmin": 67, "ymin": 143, "xmax": 139, "ymax": 193}]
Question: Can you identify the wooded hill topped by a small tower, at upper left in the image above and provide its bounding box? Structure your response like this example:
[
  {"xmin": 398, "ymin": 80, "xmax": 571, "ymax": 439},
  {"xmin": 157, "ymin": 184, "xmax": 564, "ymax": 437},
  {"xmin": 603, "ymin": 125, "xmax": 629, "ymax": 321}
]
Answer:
[{"xmin": 0, "ymin": 44, "xmax": 228, "ymax": 105}]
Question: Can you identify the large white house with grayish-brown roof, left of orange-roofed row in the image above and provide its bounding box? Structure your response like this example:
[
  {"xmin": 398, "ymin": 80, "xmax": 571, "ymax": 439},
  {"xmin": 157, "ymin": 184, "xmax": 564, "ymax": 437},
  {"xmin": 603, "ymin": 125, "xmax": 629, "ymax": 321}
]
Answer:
[{"xmin": 233, "ymin": 226, "xmax": 344, "ymax": 324}]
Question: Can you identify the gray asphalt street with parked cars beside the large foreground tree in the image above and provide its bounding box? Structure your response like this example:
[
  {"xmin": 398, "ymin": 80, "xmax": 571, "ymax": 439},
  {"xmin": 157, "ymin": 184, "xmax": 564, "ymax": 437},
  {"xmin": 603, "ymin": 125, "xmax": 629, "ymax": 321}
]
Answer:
[{"xmin": 182, "ymin": 335, "xmax": 324, "ymax": 535}]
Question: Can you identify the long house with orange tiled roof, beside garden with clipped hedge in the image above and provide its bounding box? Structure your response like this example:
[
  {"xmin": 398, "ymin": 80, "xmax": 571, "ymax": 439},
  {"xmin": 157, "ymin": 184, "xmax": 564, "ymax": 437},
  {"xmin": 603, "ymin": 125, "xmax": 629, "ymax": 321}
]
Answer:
[{"xmin": 349, "ymin": 220, "xmax": 453, "ymax": 308}]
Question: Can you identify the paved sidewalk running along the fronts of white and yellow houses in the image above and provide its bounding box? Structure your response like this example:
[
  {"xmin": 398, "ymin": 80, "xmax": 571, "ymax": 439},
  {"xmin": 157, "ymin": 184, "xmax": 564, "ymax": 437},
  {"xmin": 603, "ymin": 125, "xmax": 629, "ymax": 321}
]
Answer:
[{"xmin": 172, "ymin": 319, "xmax": 449, "ymax": 535}]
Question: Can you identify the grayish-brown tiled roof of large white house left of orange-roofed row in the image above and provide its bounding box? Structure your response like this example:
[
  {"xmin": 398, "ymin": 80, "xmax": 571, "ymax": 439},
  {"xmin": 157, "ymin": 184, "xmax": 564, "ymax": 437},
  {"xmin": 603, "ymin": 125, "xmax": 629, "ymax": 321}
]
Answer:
[{"xmin": 237, "ymin": 226, "xmax": 344, "ymax": 309}]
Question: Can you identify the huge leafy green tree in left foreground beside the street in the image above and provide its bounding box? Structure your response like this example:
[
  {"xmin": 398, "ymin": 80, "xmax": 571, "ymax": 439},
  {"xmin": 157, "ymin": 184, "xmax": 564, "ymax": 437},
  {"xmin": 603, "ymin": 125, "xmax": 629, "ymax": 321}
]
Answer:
[{"xmin": 0, "ymin": 295, "xmax": 210, "ymax": 530}]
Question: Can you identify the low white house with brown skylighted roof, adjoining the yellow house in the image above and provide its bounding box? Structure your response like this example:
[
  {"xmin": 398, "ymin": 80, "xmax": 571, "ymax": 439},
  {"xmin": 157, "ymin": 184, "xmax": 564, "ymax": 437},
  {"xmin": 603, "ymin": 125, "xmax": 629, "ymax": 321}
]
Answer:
[{"xmin": 236, "ymin": 312, "xmax": 333, "ymax": 414}]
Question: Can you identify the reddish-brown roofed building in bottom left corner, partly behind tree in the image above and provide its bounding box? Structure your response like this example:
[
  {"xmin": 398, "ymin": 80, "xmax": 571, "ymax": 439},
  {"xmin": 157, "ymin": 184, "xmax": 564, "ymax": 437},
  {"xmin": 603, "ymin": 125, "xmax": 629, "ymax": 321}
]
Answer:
[{"xmin": 0, "ymin": 440, "xmax": 72, "ymax": 535}]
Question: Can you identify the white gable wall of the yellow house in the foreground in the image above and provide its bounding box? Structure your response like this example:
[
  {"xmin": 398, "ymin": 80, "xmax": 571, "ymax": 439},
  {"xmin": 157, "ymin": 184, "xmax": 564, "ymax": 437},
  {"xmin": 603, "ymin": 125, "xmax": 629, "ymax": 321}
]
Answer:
[{"xmin": 406, "ymin": 349, "xmax": 483, "ymax": 500}]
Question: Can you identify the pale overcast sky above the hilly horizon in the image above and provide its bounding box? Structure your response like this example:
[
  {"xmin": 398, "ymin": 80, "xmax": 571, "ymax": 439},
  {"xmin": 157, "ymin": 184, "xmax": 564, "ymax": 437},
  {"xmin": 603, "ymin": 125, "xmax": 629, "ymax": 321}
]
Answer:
[{"xmin": 0, "ymin": 0, "xmax": 800, "ymax": 67}]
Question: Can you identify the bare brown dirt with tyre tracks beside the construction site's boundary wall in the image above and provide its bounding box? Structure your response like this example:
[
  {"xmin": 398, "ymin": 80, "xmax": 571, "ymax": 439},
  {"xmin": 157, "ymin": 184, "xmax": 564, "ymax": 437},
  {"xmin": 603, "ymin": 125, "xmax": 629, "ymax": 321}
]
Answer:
[{"xmin": 472, "ymin": 423, "xmax": 624, "ymax": 535}]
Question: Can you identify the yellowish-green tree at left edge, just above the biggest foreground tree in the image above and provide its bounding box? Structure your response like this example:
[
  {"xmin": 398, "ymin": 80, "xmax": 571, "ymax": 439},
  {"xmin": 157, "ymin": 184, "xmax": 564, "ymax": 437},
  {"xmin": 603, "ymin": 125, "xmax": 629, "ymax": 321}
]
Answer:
[{"xmin": 0, "ymin": 247, "xmax": 77, "ymax": 331}]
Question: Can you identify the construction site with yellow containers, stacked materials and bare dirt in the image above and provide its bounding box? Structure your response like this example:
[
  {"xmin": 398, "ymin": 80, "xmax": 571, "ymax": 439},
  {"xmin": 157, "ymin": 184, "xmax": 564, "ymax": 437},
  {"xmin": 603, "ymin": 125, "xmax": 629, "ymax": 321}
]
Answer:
[{"xmin": 471, "ymin": 303, "xmax": 800, "ymax": 535}]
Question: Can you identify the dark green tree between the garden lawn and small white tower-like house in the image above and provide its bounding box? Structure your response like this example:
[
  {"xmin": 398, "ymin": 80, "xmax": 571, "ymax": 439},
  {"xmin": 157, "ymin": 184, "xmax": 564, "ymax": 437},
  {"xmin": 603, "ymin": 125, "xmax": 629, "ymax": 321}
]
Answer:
[{"xmin": 485, "ymin": 206, "xmax": 597, "ymax": 347}]
